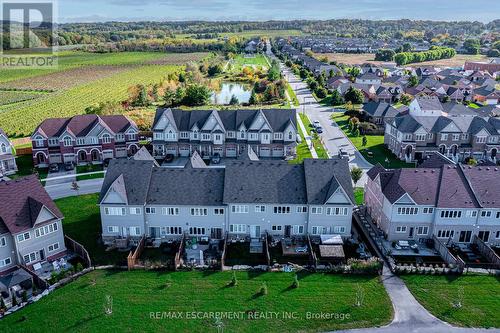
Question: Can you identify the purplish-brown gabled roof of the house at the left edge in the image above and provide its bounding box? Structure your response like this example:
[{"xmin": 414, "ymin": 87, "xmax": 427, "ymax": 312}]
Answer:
[{"xmin": 0, "ymin": 176, "xmax": 63, "ymax": 234}]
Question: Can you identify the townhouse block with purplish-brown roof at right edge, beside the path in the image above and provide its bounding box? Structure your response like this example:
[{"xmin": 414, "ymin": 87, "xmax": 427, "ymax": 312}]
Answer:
[{"xmin": 365, "ymin": 164, "xmax": 500, "ymax": 244}]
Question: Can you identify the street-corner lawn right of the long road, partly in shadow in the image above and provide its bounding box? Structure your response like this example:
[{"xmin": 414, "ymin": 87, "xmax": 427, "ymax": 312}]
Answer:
[{"xmin": 332, "ymin": 112, "xmax": 415, "ymax": 168}]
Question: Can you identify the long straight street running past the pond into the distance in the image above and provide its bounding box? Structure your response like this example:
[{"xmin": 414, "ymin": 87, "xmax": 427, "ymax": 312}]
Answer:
[{"xmin": 282, "ymin": 65, "xmax": 373, "ymax": 187}]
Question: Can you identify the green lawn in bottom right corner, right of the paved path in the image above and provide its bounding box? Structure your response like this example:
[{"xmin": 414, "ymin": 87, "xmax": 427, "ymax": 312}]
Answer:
[{"xmin": 402, "ymin": 275, "xmax": 500, "ymax": 328}]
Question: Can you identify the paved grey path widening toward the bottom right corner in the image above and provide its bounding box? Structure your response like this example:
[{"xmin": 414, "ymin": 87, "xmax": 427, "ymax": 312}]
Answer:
[{"xmin": 337, "ymin": 266, "xmax": 500, "ymax": 333}]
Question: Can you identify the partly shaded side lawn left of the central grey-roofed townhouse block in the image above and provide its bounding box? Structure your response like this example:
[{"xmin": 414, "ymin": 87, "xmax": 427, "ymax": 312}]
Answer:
[{"xmin": 55, "ymin": 194, "xmax": 128, "ymax": 265}]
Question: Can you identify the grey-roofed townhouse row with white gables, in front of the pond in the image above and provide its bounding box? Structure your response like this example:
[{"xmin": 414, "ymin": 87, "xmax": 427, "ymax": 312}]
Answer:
[{"xmin": 153, "ymin": 109, "xmax": 297, "ymax": 158}]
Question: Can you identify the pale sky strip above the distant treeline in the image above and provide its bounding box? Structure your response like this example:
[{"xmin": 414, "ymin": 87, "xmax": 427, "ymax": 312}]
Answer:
[{"xmin": 58, "ymin": 0, "xmax": 500, "ymax": 22}]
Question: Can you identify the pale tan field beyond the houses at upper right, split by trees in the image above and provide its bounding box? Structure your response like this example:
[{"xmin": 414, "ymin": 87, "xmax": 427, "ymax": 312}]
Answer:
[{"xmin": 314, "ymin": 53, "xmax": 488, "ymax": 67}]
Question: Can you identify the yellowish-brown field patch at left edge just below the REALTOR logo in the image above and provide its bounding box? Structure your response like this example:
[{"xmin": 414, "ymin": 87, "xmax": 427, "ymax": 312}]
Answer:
[{"xmin": 0, "ymin": 66, "xmax": 130, "ymax": 91}]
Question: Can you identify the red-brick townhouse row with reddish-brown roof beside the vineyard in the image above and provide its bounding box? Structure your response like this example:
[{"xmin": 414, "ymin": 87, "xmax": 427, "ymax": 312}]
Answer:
[{"xmin": 31, "ymin": 115, "xmax": 139, "ymax": 167}]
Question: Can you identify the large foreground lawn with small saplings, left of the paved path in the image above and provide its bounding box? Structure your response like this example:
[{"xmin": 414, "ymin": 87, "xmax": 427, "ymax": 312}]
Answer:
[{"xmin": 0, "ymin": 271, "xmax": 392, "ymax": 333}]
